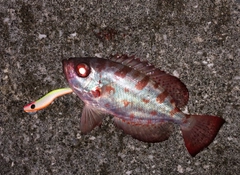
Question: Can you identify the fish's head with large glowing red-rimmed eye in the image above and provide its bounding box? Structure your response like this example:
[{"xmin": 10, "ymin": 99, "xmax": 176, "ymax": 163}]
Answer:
[{"xmin": 62, "ymin": 57, "xmax": 101, "ymax": 101}]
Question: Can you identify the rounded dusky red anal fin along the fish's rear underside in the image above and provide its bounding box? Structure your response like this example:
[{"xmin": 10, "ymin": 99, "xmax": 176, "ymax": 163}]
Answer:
[{"xmin": 114, "ymin": 117, "xmax": 173, "ymax": 143}]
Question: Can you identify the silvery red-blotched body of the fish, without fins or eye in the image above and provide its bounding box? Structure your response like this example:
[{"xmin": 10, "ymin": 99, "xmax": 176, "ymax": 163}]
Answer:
[{"xmin": 62, "ymin": 58, "xmax": 185, "ymax": 123}]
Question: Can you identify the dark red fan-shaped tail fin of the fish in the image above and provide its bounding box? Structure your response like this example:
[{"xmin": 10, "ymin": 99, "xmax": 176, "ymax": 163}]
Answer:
[{"xmin": 181, "ymin": 115, "xmax": 225, "ymax": 157}]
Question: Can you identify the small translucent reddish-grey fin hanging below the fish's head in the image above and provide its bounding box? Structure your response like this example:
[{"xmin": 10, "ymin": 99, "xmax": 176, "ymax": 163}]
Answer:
[{"xmin": 80, "ymin": 105, "xmax": 103, "ymax": 134}]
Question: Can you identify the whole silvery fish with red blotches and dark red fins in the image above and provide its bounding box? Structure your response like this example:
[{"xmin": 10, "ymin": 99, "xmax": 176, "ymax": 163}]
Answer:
[{"xmin": 62, "ymin": 55, "xmax": 225, "ymax": 157}]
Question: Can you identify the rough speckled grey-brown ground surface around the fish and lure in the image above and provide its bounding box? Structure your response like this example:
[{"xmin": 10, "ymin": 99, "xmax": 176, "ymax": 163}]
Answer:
[{"xmin": 0, "ymin": 0, "xmax": 240, "ymax": 175}]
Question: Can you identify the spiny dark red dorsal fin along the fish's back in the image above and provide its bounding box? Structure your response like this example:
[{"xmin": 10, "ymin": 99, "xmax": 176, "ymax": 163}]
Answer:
[{"xmin": 109, "ymin": 54, "xmax": 189, "ymax": 108}]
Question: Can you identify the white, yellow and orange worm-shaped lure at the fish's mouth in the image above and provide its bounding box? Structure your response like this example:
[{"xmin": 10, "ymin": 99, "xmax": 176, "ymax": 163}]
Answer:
[{"xmin": 23, "ymin": 88, "xmax": 73, "ymax": 113}]
